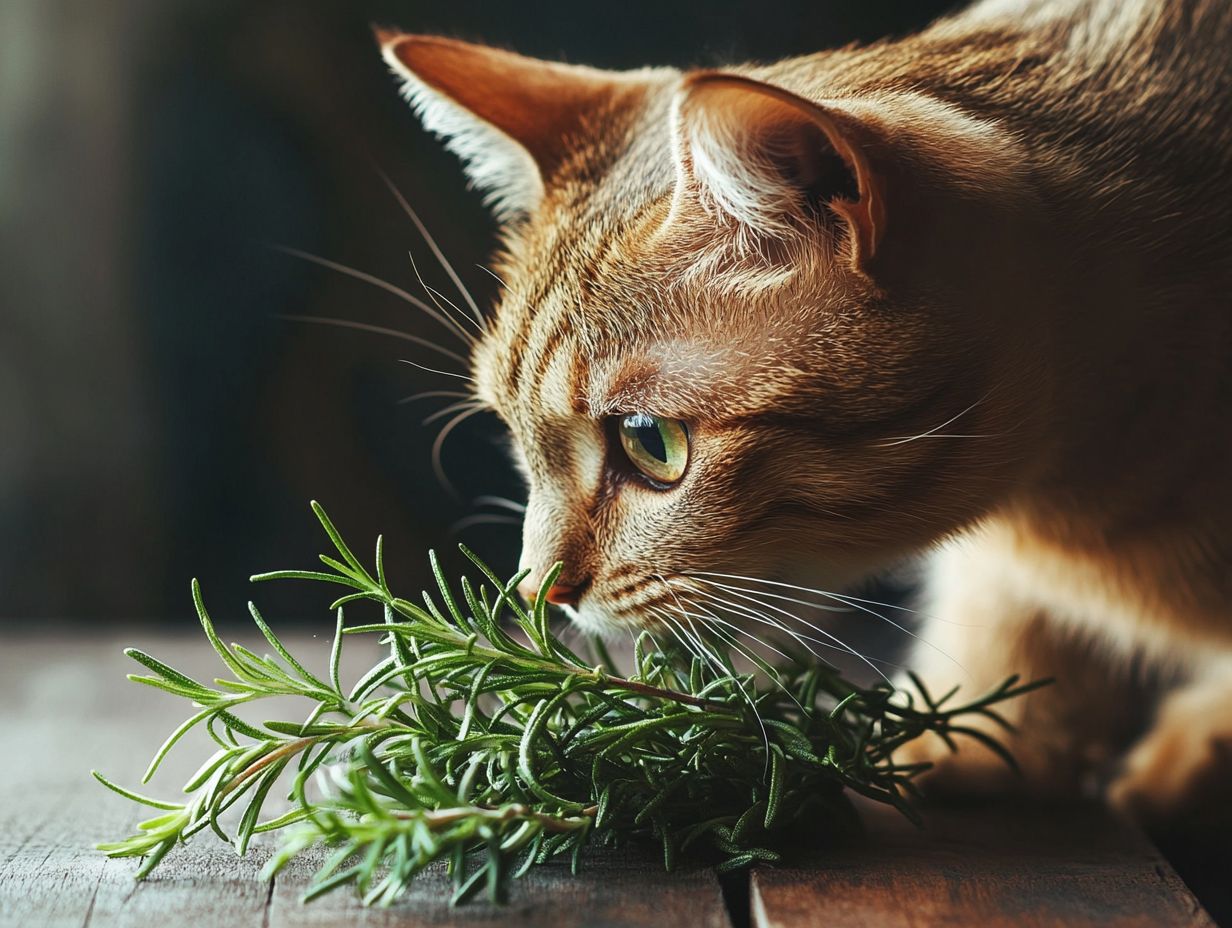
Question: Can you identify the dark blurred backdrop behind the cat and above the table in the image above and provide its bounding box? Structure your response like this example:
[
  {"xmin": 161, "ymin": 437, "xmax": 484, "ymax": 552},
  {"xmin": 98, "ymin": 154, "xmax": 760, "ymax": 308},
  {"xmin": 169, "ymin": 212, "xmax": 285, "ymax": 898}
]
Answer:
[{"xmin": 0, "ymin": 0, "xmax": 950, "ymax": 627}]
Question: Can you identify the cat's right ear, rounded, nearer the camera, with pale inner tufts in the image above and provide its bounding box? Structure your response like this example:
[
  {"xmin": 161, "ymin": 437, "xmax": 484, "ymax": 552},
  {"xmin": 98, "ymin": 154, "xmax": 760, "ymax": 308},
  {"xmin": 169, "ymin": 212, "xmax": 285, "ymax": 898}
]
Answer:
[{"xmin": 674, "ymin": 71, "xmax": 886, "ymax": 267}]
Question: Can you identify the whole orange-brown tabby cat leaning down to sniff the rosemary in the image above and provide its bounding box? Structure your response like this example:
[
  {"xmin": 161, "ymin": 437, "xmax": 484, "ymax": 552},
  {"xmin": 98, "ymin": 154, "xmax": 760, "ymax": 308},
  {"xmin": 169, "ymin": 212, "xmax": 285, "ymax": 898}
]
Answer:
[{"xmin": 379, "ymin": 0, "xmax": 1232, "ymax": 816}]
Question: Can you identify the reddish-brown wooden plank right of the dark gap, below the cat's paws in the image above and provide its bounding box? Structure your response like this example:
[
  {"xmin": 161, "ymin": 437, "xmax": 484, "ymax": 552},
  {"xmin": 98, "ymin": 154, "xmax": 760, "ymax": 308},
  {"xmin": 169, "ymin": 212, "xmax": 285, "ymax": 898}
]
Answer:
[{"xmin": 752, "ymin": 804, "xmax": 1215, "ymax": 928}]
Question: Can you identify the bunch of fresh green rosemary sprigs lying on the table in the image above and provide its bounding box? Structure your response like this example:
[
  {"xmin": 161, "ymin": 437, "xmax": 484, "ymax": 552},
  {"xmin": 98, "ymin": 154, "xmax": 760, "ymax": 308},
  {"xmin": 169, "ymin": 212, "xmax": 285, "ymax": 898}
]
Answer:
[{"xmin": 94, "ymin": 503, "xmax": 1036, "ymax": 905}]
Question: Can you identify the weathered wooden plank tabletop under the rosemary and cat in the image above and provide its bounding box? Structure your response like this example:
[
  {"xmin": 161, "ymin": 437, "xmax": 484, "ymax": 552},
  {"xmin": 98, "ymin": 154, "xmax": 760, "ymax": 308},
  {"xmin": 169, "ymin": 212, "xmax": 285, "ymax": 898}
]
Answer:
[{"xmin": 0, "ymin": 627, "xmax": 1214, "ymax": 928}]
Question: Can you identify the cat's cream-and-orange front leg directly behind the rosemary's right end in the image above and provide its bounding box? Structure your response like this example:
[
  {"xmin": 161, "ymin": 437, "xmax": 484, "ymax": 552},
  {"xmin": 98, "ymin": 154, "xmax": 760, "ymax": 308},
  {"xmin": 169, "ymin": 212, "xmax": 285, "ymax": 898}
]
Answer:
[{"xmin": 894, "ymin": 542, "xmax": 1129, "ymax": 796}]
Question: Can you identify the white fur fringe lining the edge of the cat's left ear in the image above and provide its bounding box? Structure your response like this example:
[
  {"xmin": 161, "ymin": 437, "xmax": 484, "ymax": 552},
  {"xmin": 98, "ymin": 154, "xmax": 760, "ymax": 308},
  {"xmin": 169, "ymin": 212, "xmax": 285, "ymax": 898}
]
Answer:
[{"xmin": 382, "ymin": 43, "xmax": 543, "ymax": 221}]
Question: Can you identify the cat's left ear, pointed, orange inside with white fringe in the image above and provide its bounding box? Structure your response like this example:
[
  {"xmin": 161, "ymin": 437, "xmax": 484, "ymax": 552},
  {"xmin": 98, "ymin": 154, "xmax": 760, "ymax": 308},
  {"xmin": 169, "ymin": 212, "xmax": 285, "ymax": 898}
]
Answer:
[{"xmin": 376, "ymin": 28, "xmax": 616, "ymax": 218}]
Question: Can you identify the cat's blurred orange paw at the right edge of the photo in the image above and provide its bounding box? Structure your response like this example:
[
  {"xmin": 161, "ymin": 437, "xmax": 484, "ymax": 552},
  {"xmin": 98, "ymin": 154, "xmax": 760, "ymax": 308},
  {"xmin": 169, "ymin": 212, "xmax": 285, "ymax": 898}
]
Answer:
[{"xmin": 1109, "ymin": 652, "xmax": 1232, "ymax": 821}]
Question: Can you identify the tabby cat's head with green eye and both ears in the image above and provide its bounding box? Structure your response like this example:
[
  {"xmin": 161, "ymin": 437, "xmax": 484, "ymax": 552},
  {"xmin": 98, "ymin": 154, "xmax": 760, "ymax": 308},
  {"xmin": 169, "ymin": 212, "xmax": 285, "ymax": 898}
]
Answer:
[{"xmin": 379, "ymin": 33, "xmax": 1044, "ymax": 630}]
